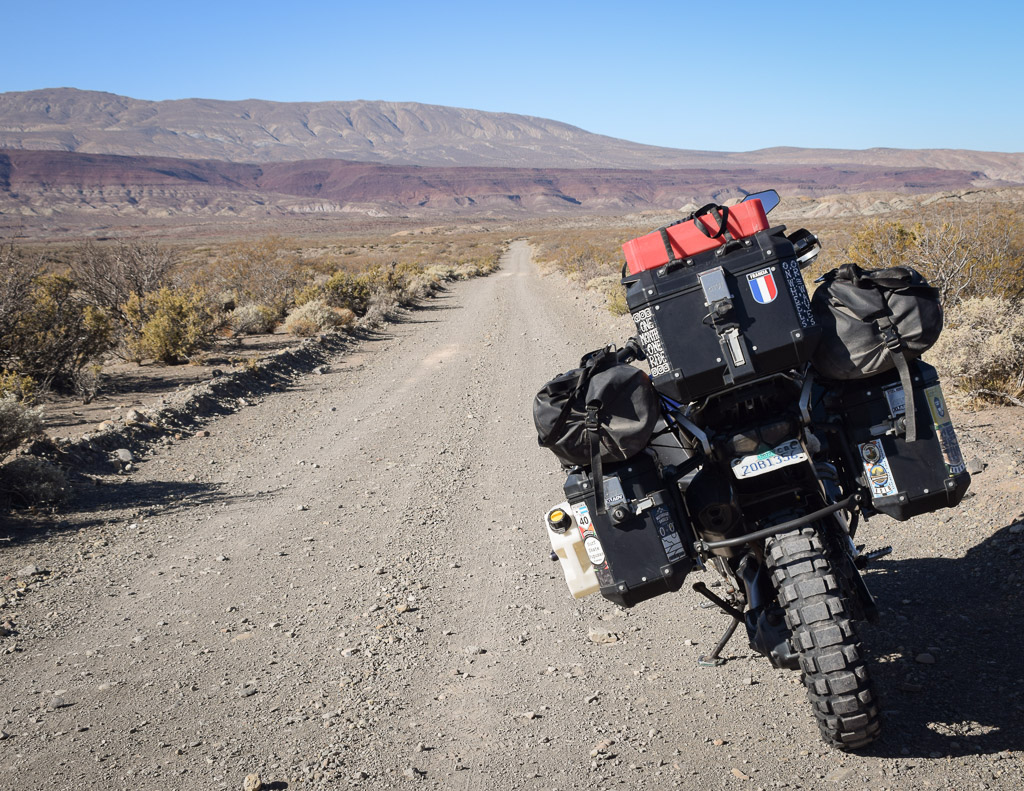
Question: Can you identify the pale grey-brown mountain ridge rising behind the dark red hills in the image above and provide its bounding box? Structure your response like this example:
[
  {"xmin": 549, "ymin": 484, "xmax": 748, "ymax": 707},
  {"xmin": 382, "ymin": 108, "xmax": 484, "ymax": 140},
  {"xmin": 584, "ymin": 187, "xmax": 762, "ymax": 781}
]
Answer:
[{"xmin": 0, "ymin": 88, "xmax": 1024, "ymax": 183}]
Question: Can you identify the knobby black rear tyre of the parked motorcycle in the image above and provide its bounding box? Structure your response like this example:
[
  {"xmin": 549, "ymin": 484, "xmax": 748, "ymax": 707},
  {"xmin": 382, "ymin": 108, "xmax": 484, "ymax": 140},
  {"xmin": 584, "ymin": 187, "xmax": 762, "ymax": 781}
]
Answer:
[{"xmin": 765, "ymin": 528, "xmax": 881, "ymax": 750}]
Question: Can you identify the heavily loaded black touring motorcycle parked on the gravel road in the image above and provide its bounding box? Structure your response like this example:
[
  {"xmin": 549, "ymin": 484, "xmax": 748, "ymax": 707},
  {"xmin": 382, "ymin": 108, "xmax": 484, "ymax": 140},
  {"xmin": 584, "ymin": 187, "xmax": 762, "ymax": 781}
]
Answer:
[{"xmin": 535, "ymin": 191, "xmax": 970, "ymax": 750}]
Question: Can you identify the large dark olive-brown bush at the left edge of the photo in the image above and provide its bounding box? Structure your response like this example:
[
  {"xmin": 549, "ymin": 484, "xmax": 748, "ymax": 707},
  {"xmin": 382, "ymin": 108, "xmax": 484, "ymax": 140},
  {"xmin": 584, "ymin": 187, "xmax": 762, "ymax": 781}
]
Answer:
[{"xmin": 0, "ymin": 275, "xmax": 114, "ymax": 389}]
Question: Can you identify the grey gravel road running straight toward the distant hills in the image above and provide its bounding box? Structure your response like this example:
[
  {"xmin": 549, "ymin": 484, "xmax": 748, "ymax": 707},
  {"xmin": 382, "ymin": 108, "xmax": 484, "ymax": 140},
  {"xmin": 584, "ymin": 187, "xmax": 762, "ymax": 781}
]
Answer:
[{"xmin": 0, "ymin": 243, "xmax": 1024, "ymax": 791}]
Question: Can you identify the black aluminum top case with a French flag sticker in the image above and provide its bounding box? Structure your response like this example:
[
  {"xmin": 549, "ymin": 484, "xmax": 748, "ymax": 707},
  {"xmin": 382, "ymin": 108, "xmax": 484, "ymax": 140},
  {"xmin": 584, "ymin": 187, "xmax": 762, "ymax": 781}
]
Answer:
[{"xmin": 623, "ymin": 225, "xmax": 821, "ymax": 403}]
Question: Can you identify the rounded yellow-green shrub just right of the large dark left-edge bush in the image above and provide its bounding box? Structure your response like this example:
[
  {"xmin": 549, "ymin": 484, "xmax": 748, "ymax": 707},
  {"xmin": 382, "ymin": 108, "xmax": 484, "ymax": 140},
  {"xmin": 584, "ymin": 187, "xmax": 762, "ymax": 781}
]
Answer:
[{"xmin": 125, "ymin": 286, "xmax": 223, "ymax": 364}]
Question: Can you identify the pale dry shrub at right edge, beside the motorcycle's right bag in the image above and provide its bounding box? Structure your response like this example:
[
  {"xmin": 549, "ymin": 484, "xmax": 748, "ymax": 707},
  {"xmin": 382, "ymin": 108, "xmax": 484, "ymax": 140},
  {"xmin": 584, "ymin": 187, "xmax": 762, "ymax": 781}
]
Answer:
[{"xmin": 929, "ymin": 296, "xmax": 1024, "ymax": 398}]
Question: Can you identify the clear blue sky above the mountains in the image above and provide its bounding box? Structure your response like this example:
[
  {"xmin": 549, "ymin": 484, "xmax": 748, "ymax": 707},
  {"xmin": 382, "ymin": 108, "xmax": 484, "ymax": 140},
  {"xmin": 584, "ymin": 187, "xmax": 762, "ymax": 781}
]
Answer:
[{"xmin": 0, "ymin": 0, "xmax": 1024, "ymax": 152}]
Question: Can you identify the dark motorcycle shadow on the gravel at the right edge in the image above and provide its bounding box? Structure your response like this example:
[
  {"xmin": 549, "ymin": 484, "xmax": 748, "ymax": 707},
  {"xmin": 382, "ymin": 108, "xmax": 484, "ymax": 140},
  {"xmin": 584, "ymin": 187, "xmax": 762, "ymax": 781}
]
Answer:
[{"xmin": 861, "ymin": 517, "xmax": 1024, "ymax": 757}]
